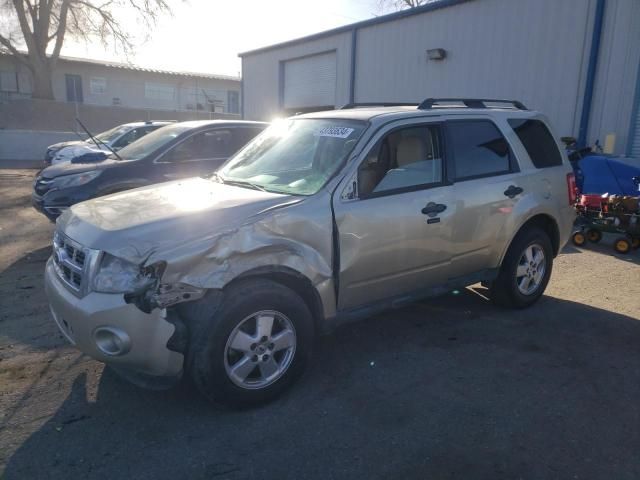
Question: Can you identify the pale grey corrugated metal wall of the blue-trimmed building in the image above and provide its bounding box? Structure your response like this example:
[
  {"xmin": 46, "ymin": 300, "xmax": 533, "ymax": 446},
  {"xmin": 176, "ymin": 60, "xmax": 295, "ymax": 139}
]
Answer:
[{"xmin": 243, "ymin": 0, "xmax": 640, "ymax": 153}]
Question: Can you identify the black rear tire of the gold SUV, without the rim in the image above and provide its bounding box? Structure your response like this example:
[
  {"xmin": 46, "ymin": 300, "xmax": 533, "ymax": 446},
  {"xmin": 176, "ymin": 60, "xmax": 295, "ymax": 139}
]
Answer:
[{"xmin": 490, "ymin": 227, "xmax": 552, "ymax": 308}]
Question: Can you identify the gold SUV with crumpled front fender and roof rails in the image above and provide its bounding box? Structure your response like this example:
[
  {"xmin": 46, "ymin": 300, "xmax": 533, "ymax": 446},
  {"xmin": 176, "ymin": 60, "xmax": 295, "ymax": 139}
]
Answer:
[{"xmin": 45, "ymin": 99, "xmax": 575, "ymax": 406}]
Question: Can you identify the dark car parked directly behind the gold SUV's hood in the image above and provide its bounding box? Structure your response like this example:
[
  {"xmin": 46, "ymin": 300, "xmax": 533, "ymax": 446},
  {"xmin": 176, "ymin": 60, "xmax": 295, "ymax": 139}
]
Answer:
[{"xmin": 31, "ymin": 120, "xmax": 268, "ymax": 221}]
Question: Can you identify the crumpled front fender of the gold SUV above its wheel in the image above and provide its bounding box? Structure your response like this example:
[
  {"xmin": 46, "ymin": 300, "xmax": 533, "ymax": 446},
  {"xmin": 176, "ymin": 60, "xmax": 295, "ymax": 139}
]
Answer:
[{"xmin": 154, "ymin": 197, "xmax": 335, "ymax": 315}]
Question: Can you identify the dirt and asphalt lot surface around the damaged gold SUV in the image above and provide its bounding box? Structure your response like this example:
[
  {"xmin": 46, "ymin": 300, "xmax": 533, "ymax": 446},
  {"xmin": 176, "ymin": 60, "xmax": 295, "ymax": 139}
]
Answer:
[{"xmin": 0, "ymin": 170, "xmax": 640, "ymax": 479}]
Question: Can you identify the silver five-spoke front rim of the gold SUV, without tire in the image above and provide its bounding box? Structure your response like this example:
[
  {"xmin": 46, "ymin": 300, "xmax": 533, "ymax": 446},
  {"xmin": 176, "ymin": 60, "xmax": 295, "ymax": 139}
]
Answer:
[{"xmin": 224, "ymin": 310, "xmax": 296, "ymax": 389}]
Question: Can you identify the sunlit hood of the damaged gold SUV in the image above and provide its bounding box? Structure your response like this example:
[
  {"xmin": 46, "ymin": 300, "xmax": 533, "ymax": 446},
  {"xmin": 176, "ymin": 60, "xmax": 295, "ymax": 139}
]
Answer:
[{"xmin": 58, "ymin": 178, "xmax": 301, "ymax": 264}]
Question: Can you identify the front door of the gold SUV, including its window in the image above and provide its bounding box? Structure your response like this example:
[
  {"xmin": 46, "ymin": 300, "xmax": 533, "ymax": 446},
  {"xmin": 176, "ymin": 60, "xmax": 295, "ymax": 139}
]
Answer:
[{"xmin": 334, "ymin": 121, "xmax": 455, "ymax": 310}]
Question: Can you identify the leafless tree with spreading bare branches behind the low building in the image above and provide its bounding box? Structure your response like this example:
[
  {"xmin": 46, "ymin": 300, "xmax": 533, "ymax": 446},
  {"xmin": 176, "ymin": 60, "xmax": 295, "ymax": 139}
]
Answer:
[{"xmin": 0, "ymin": 0, "xmax": 171, "ymax": 99}]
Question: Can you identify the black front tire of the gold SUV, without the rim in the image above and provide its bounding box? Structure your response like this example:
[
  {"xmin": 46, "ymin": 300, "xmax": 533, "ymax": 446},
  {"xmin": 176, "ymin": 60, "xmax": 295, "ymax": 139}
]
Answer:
[{"xmin": 187, "ymin": 279, "xmax": 315, "ymax": 408}]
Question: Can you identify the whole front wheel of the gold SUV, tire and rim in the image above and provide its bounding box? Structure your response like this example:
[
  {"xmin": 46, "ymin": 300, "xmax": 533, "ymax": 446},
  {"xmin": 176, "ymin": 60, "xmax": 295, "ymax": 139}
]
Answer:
[{"xmin": 182, "ymin": 278, "xmax": 315, "ymax": 408}]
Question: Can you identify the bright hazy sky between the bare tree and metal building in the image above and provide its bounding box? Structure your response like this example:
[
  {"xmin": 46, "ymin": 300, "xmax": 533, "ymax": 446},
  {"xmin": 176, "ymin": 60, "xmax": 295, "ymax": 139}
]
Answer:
[{"xmin": 62, "ymin": 0, "xmax": 380, "ymax": 75}]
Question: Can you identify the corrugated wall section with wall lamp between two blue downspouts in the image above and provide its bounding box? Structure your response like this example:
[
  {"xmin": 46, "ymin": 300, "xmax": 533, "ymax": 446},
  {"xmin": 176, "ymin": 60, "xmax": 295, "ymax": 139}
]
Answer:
[{"xmin": 355, "ymin": 0, "xmax": 593, "ymax": 135}]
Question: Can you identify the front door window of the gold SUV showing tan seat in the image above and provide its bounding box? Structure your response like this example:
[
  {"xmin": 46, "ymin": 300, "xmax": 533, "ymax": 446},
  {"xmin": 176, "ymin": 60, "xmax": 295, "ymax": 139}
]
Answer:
[{"xmin": 358, "ymin": 125, "xmax": 442, "ymax": 198}]
